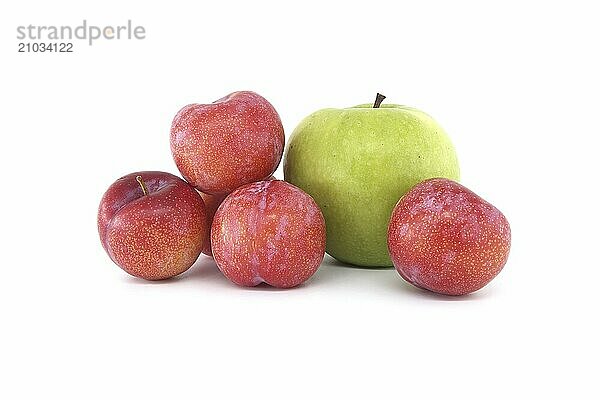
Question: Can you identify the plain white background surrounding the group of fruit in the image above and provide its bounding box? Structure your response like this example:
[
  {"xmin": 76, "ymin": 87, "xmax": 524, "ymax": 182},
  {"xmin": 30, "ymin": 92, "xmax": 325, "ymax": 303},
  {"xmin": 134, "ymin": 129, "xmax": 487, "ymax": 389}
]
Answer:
[{"xmin": 0, "ymin": 0, "xmax": 600, "ymax": 399}]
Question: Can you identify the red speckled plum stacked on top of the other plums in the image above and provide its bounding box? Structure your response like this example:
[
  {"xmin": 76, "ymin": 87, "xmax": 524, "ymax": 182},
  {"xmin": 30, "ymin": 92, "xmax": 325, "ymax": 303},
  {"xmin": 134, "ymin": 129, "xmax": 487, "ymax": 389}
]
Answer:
[{"xmin": 171, "ymin": 92, "xmax": 285, "ymax": 194}]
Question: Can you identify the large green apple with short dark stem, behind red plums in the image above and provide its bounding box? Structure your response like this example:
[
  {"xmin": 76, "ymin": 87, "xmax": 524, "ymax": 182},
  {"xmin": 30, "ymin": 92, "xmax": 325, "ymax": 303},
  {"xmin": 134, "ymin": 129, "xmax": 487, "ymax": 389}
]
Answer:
[{"xmin": 283, "ymin": 94, "xmax": 459, "ymax": 267}]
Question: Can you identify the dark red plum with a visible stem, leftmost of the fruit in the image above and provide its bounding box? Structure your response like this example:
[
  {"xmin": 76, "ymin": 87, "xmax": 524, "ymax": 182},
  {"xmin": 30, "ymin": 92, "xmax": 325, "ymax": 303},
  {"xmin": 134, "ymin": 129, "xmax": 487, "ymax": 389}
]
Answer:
[{"xmin": 98, "ymin": 171, "xmax": 208, "ymax": 280}]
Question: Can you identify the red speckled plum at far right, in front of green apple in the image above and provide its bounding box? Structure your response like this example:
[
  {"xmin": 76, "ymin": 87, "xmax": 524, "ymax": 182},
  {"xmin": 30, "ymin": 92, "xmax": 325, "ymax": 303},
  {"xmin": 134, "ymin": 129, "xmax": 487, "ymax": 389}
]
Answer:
[{"xmin": 387, "ymin": 178, "xmax": 510, "ymax": 295}]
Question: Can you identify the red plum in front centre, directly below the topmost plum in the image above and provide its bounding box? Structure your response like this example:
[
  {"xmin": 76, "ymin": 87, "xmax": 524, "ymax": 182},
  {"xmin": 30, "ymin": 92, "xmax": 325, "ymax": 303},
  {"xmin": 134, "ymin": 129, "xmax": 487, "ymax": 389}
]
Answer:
[{"xmin": 211, "ymin": 180, "xmax": 325, "ymax": 288}]
